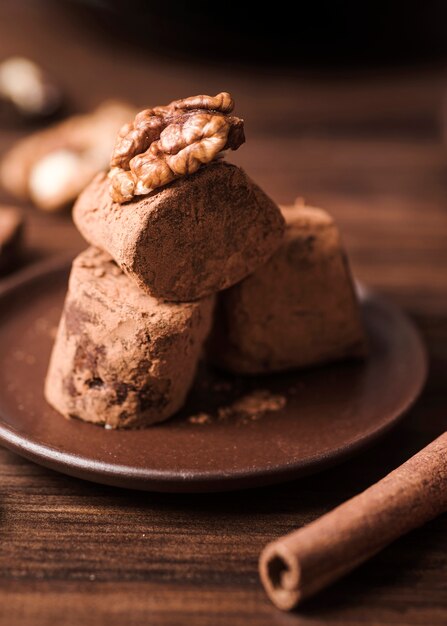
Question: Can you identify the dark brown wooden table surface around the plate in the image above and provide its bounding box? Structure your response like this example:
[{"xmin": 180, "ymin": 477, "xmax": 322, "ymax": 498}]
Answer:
[{"xmin": 0, "ymin": 1, "xmax": 447, "ymax": 626}]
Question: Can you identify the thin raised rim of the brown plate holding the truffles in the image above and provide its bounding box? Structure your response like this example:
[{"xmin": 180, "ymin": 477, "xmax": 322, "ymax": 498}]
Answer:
[{"xmin": 0, "ymin": 255, "xmax": 428, "ymax": 493}]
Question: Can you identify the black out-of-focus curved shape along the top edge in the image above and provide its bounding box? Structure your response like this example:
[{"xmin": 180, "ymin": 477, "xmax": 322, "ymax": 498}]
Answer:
[{"xmin": 64, "ymin": 0, "xmax": 447, "ymax": 68}]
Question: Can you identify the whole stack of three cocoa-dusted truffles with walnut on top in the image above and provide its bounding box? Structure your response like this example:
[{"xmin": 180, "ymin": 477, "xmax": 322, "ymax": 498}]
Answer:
[{"xmin": 46, "ymin": 93, "xmax": 365, "ymax": 428}]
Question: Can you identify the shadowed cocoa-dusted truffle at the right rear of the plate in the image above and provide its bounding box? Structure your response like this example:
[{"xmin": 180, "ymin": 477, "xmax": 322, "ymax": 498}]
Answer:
[{"xmin": 209, "ymin": 206, "xmax": 365, "ymax": 374}]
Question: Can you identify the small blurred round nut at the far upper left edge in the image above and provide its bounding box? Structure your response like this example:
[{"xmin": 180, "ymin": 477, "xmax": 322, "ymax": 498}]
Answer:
[{"xmin": 0, "ymin": 57, "xmax": 63, "ymax": 123}]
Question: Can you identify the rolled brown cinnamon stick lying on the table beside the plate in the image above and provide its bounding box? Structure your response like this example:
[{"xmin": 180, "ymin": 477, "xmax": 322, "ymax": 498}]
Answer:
[{"xmin": 259, "ymin": 432, "xmax": 447, "ymax": 610}]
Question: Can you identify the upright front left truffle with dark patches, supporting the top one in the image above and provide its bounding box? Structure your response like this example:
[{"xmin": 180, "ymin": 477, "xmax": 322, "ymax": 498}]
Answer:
[{"xmin": 45, "ymin": 248, "xmax": 213, "ymax": 428}]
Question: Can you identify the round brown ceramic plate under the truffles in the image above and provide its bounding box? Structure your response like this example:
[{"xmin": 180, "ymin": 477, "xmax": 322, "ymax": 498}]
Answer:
[{"xmin": 0, "ymin": 256, "xmax": 426, "ymax": 492}]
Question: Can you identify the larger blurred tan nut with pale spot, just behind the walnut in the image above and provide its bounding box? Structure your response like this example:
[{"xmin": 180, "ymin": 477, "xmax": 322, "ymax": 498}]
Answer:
[{"xmin": 0, "ymin": 101, "xmax": 136, "ymax": 211}]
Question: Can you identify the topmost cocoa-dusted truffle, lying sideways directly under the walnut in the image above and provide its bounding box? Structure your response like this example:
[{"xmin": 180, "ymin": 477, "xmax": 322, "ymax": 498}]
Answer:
[{"xmin": 74, "ymin": 161, "xmax": 284, "ymax": 302}]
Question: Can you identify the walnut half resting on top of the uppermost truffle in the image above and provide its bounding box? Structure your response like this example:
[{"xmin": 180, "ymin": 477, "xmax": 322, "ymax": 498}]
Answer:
[{"xmin": 109, "ymin": 92, "xmax": 245, "ymax": 203}]
